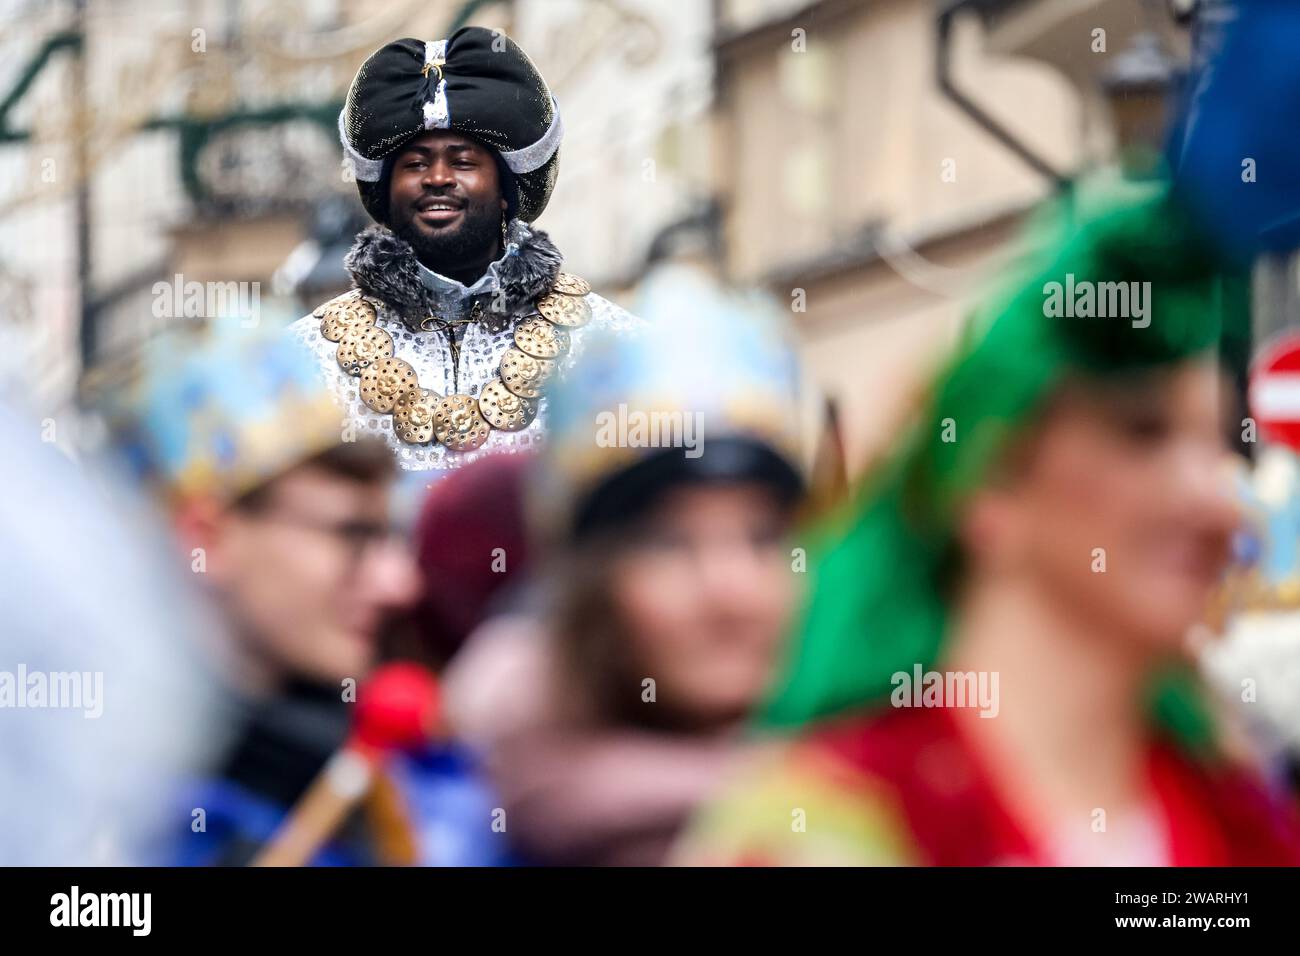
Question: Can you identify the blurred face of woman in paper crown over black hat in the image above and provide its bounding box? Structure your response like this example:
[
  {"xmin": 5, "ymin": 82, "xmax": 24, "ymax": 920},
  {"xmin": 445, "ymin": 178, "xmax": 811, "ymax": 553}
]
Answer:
[{"xmin": 610, "ymin": 485, "xmax": 796, "ymax": 726}]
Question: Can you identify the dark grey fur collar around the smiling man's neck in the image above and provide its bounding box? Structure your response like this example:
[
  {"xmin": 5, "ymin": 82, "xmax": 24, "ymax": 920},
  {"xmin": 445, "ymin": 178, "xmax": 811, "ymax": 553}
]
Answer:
[{"xmin": 343, "ymin": 220, "xmax": 563, "ymax": 329}]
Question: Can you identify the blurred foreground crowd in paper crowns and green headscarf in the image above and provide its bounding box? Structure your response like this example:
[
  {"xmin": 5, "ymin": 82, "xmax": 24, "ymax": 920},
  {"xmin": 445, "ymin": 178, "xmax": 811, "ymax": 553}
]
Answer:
[{"xmin": 0, "ymin": 3, "xmax": 1300, "ymax": 866}]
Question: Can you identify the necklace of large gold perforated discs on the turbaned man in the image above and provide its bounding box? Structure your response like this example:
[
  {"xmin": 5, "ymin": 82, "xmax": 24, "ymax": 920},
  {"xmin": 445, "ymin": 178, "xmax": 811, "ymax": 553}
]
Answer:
[{"xmin": 313, "ymin": 272, "xmax": 592, "ymax": 451}]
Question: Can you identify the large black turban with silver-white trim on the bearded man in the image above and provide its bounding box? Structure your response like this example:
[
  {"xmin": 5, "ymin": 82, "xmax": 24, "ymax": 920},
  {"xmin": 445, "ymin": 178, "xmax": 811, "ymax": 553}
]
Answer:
[{"xmin": 338, "ymin": 26, "xmax": 564, "ymax": 222}]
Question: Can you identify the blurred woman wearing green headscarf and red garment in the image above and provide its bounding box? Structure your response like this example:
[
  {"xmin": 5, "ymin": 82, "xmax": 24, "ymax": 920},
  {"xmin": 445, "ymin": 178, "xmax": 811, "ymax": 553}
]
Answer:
[{"xmin": 683, "ymin": 194, "xmax": 1300, "ymax": 865}]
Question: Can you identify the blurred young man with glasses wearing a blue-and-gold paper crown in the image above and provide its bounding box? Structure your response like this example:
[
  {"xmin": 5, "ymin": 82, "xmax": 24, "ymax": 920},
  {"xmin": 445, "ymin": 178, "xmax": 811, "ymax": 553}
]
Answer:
[{"xmin": 92, "ymin": 321, "xmax": 495, "ymax": 865}]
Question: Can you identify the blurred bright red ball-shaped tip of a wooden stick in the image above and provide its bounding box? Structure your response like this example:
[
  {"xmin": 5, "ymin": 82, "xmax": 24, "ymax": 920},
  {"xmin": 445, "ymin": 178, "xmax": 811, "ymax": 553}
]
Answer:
[{"xmin": 352, "ymin": 662, "xmax": 441, "ymax": 750}]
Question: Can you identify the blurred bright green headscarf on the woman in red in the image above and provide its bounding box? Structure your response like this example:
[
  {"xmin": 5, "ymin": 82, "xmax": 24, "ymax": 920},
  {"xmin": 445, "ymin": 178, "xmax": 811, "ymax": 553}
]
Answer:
[{"xmin": 767, "ymin": 187, "xmax": 1248, "ymax": 745}]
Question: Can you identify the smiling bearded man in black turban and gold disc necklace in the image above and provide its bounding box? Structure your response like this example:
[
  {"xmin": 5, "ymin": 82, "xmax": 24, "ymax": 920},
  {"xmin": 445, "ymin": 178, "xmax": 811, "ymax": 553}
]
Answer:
[{"xmin": 293, "ymin": 27, "xmax": 634, "ymax": 479}]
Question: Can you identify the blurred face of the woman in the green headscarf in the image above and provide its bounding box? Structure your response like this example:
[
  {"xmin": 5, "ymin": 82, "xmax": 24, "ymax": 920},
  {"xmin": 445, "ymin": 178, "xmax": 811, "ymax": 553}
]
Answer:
[{"xmin": 965, "ymin": 363, "xmax": 1236, "ymax": 652}]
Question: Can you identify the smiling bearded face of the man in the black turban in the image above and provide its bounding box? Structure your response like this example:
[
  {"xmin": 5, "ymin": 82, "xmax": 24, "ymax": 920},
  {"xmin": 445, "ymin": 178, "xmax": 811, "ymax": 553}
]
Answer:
[{"xmin": 389, "ymin": 130, "xmax": 506, "ymax": 276}]
